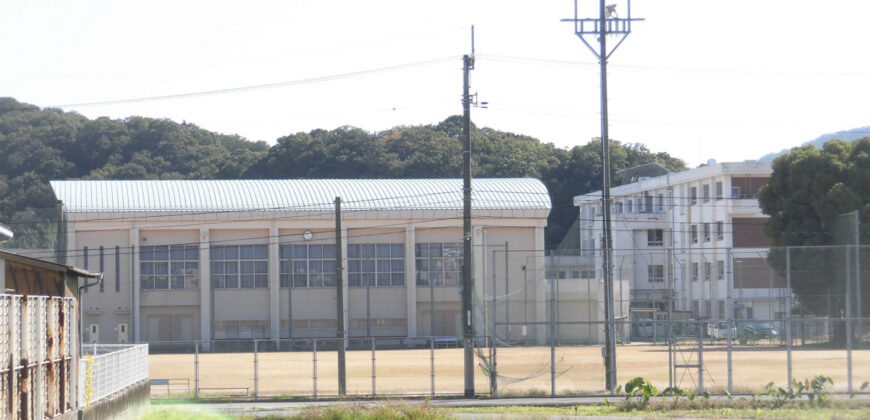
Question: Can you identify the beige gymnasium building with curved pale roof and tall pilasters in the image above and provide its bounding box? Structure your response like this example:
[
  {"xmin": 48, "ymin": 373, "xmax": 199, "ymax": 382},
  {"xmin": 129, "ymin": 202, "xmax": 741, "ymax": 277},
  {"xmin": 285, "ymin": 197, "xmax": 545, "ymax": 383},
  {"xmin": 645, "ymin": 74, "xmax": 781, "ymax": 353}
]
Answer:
[{"xmin": 51, "ymin": 179, "xmax": 551, "ymax": 343}]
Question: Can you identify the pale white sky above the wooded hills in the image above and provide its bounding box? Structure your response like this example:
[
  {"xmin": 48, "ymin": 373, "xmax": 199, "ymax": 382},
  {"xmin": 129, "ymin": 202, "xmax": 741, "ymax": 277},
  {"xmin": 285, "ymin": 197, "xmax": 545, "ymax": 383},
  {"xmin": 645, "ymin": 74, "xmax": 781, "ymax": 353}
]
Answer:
[{"xmin": 0, "ymin": 0, "xmax": 870, "ymax": 167}]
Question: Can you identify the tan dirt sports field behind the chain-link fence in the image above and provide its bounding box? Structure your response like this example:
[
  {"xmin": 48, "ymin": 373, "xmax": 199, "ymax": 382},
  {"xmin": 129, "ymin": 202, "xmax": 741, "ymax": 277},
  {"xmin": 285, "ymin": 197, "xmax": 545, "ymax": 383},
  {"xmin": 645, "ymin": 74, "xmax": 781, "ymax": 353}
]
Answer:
[{"xmin": 150, "ymin": 345, "xmax": 870, "ymax": 396}]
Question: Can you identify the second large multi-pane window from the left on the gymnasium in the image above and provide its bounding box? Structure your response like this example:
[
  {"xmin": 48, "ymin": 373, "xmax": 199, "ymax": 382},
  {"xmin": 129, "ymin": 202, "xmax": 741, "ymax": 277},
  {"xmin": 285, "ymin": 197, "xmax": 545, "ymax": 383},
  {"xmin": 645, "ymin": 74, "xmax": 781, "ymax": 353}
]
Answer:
[{"xmin": 210, "ymin": 245, "xmax": 269, "ymax": 289}]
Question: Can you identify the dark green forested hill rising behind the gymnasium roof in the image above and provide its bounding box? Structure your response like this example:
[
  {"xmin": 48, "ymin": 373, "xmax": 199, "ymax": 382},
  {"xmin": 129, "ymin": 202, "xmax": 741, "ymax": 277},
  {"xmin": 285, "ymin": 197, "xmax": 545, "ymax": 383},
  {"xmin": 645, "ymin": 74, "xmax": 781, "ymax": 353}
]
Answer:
[{"xmin": 0, "ymin": 98, "xmax": 685, "ymax": 248}]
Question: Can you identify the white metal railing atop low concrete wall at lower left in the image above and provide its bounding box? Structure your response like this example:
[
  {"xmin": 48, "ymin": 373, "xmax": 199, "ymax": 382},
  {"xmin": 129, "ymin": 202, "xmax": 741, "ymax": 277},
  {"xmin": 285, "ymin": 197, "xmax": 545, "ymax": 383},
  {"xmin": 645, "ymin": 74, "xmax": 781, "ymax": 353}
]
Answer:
[{"xmin": 79, "ymin": 344, "xmax": 148, "ymax": 407}]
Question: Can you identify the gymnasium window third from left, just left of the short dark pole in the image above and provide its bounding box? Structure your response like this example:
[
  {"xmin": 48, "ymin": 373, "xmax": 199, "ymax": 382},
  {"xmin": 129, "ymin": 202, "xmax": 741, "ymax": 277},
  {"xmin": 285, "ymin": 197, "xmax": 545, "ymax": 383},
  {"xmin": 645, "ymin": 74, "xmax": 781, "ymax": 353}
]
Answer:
[{"xmin": 279, "ymin": 244, "xmax": 336, "ymax": 287}]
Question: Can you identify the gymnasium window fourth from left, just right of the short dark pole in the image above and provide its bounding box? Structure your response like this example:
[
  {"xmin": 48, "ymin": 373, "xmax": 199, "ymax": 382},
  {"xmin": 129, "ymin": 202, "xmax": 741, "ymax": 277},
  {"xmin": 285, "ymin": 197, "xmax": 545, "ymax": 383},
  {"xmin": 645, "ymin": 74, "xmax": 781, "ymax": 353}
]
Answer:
[{"xmin": 347, "ymin": 244, "xmax": 405, "ymax": 287}]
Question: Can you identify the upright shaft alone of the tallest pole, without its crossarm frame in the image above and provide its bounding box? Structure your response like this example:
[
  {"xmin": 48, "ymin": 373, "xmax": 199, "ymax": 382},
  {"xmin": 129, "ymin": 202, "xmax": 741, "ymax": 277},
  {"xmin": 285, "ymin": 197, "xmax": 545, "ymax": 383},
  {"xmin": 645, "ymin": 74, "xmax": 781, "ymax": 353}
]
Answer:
[{"xmin": 598, "ymin": 0, "xmax": 616, "ymax": 393}]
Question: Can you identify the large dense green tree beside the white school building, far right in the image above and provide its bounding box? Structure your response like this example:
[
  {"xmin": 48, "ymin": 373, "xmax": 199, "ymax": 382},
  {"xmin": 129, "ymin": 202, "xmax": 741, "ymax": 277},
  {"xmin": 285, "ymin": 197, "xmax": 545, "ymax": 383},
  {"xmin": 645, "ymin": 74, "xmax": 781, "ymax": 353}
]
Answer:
[{"xmin": 759, "ymin": 137, "xmax": 870, "ymax": 316}]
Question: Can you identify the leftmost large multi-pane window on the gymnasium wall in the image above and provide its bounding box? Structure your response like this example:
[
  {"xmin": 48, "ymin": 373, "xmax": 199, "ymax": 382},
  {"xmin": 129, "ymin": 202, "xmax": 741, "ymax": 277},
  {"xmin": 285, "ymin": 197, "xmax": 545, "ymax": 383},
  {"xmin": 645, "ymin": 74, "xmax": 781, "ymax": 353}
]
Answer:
[{"xmin": 139, "ymin": 245, "xmax": 199, "ymax": 290}]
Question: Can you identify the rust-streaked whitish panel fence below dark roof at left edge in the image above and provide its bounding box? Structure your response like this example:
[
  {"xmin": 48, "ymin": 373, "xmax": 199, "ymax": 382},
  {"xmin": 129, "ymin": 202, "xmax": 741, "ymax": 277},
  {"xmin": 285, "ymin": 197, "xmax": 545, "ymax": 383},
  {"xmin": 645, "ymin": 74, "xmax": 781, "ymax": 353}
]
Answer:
[{"xmin": 0, "ymin": 294, "xmax": 78, "ymax": 420}]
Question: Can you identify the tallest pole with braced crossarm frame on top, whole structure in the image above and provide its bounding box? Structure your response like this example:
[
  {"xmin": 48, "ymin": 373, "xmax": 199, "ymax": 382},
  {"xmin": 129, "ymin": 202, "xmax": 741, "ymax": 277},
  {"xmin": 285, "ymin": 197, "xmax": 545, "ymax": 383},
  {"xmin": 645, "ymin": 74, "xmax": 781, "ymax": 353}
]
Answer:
[{"xmin": 562, "ymin": 0, "xmax": 643, "ymax": 393}]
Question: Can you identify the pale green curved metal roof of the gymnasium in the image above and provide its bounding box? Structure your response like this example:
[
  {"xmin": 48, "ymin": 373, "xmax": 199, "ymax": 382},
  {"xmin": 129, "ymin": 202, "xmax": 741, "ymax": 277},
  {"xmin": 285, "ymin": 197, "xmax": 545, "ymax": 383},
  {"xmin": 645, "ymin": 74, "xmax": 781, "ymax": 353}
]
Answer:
[{"xmin": 51, "ymin": 178, "xmax": 551, "ymax": 213}]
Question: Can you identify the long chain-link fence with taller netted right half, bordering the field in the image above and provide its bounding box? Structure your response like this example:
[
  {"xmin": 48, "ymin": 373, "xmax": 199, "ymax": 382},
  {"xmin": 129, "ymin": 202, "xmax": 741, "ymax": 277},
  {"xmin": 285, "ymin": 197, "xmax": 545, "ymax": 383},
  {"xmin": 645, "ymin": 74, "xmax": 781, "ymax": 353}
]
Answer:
[{"xmin": 143, "ymin": 246, "xmax": 870, "ymax": 398}]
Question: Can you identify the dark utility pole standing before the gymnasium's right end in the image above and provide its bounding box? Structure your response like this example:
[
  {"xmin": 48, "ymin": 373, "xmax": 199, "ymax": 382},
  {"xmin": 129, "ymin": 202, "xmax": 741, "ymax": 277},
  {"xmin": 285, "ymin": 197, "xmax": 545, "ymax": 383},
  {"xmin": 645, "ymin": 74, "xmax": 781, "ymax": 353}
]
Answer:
[{"xmin": 462, "ymin": 26, "xmax": 474, "ymax": 398}]
